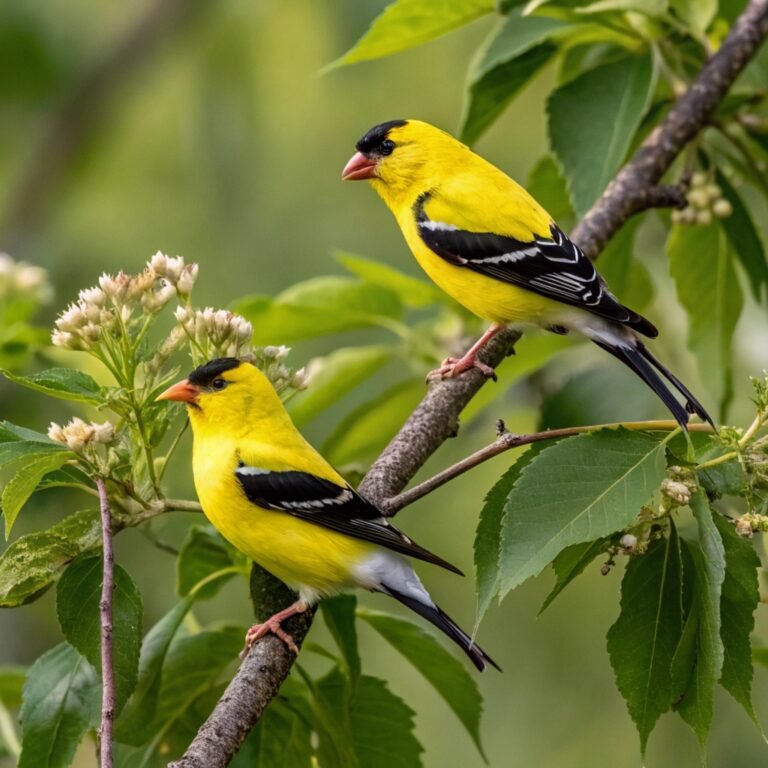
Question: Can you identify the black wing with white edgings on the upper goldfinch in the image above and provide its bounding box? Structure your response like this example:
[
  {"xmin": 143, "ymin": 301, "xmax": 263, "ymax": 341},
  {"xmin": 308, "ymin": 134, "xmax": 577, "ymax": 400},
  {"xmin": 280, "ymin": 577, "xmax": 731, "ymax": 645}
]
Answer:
[{"xmin": 413, "ymin": 192, "xmax": 658, "ymax": 337}]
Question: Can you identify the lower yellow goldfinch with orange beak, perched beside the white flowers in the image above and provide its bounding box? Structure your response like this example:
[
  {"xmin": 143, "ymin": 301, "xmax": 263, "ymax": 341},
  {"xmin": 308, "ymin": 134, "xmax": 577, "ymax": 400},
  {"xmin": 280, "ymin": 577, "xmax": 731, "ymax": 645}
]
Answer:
[{"xmin": 158, "ymin": 357, "xmax": 496, "ymax": 670}]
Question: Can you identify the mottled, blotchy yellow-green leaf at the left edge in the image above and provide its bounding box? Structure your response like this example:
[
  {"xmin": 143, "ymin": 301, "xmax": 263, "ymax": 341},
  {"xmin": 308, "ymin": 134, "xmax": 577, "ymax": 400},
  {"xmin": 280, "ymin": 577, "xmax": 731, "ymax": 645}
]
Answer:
[{"xmin": 0, "ymin": 509, "xmax": 101, "ymax": 608}]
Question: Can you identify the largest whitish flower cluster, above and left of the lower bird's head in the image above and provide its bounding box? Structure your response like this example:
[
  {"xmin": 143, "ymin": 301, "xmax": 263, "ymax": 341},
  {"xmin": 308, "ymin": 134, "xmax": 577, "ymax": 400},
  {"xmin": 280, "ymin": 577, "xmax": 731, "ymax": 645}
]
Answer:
[{"xmin": 51, "ymin": 252, "xmax": 198, "ymax": 350}]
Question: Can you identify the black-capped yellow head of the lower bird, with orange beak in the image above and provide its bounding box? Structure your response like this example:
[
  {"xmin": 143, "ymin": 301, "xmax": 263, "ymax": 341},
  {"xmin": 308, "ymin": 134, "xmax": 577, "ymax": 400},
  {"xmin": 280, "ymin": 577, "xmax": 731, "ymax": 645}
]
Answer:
[{"xmin": 157, "ymin": 357, "xmax": 284, "ymax": 434}]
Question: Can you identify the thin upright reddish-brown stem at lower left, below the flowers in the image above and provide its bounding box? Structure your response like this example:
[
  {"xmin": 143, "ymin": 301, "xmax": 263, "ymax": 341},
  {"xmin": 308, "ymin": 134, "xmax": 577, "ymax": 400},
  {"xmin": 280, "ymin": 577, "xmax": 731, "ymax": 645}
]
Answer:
[{"xmin": 96, "ymin": 478, "xmax": 115, "ymax": 768}]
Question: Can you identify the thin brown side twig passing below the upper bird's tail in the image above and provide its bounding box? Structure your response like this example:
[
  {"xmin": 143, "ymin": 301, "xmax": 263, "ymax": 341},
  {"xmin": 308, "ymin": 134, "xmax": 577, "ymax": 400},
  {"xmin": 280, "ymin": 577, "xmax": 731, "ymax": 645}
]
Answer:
[{"xmin": 384, "ymin": 419, "xmax": 712, "ymax": 516}]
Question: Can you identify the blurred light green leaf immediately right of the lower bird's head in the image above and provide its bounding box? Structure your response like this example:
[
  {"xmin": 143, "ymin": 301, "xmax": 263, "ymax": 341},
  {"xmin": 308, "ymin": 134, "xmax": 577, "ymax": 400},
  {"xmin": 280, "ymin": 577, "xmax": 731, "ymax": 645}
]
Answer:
[{"xmin": 288, "ymin": 345, "xmax": 395, "ymax": 428}]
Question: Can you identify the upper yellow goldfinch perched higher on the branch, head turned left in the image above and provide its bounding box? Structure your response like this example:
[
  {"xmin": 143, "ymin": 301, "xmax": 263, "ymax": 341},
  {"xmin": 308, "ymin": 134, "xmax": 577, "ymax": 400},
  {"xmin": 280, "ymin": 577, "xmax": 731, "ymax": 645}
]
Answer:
[{"xmin": 342, "ymin": 120, "xmax": 712, "ymax": 428}]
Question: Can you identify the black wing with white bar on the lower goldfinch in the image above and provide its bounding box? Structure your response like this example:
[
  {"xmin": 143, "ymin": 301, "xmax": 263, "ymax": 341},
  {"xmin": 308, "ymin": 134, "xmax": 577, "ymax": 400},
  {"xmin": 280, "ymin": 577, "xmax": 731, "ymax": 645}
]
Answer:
[{"xmin": 235, "ymin": 464, "xmax": 463, "ymax": 575}]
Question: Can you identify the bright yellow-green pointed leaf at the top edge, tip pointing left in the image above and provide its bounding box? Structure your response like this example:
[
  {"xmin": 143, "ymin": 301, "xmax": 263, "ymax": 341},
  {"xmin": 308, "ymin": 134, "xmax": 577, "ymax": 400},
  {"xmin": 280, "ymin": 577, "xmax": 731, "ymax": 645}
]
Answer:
[{"xmin": 328, "ymin": 0, "xmax": 493, "ymax": 68}]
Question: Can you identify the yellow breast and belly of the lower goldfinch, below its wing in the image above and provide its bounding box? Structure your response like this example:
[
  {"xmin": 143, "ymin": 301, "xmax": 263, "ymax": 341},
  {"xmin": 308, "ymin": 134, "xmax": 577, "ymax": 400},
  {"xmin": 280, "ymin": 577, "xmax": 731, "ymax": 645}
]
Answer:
[{"xmin": 193, "ymin": 440, "xmax": 374, "ymax": 596}]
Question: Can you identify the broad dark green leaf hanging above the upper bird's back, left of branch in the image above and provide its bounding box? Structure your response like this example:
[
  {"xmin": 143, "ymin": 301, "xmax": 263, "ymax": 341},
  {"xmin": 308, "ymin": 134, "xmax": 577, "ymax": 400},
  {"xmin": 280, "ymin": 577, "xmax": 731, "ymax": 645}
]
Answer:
[{"xmin": 547, "ymin": 53, "xmax": 656, "ymax": 217}]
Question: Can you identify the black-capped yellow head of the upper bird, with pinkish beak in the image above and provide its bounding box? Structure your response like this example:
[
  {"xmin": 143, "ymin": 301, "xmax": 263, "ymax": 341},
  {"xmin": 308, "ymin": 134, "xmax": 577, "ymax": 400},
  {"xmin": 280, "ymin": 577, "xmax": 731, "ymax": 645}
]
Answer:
[{"xmin": 341, "ymin": 120, "xmax": 469, "ymax": 203}]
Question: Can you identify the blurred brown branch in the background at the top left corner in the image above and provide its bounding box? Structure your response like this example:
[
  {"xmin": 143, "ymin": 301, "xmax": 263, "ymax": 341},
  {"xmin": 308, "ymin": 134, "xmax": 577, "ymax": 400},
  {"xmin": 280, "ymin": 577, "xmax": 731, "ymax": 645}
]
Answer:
[{"xmin": 0, "ymin": 0, "xmax": 208, "ymax": 249}]
